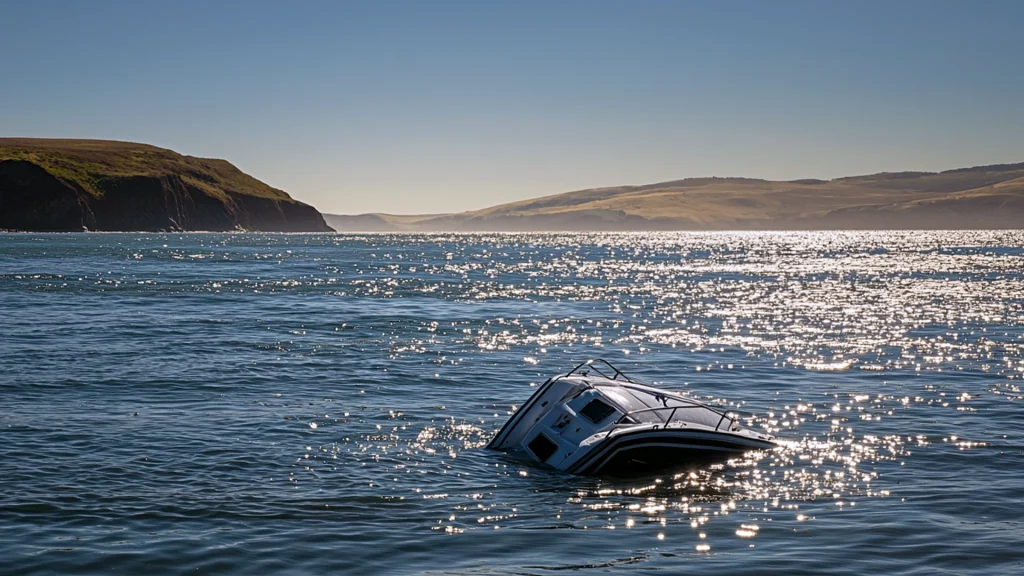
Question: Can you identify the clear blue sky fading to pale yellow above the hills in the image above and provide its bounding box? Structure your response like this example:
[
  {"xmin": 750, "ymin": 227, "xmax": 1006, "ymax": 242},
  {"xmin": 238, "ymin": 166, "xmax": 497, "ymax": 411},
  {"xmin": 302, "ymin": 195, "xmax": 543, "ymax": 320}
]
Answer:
[{"xmin": 0, "ymin": 0, "xmax": 1024, "ymax": 213}]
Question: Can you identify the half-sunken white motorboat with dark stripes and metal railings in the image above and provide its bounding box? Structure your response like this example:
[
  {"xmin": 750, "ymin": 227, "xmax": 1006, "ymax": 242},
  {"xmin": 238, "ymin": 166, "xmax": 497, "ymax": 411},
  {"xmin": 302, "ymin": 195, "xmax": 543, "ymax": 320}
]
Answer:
[{"xmin": 487, "ymin": 360, "xmax": 775, "ymax": 476}]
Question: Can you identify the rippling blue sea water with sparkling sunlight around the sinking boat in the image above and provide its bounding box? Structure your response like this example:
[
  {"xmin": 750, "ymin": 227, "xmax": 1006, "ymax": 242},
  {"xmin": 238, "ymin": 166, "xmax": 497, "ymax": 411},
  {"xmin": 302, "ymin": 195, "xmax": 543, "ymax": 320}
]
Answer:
[{"xmin": 0, "ymin": 232, "xmax": 1024, "ymax": 575}]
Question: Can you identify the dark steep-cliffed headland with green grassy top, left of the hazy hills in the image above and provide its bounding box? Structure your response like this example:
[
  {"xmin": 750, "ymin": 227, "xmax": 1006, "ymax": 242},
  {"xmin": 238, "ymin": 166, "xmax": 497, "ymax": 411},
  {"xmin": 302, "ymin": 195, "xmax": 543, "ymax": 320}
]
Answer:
[{"xmin": 0, "ymin": 138, "xmax": 331, "ymax": 232}]
